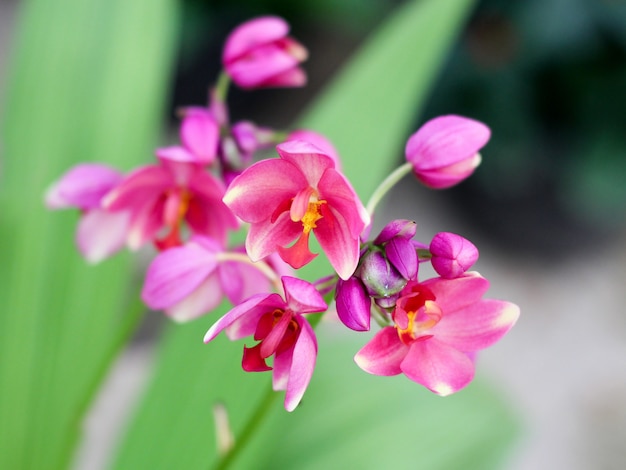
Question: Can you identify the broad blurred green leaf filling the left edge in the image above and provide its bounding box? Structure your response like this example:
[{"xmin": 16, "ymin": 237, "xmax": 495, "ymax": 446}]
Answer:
[{"xmin": 0, "ymin": 0, "xmax": 176, "ymax": 469}]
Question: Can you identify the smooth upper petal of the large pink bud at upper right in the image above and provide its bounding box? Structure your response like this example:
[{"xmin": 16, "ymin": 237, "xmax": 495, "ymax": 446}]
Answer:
[{"xmin": 405, "ymin": 115, "xmax": 491, "ymax": 170}]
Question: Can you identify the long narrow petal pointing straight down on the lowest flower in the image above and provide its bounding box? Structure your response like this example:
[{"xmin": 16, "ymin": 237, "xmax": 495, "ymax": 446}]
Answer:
[{"xmin": 285, "ymin": 316, "xmax": 317, "ymax": 411}]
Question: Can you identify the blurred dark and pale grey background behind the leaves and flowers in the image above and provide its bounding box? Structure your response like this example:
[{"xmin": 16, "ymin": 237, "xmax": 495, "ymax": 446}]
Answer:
[{"xmin": 0, "ymin": 0, "xmax": 626, "ymax": 470}]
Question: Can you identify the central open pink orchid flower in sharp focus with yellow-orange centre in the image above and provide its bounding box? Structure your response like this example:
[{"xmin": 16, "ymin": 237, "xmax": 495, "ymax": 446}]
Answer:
[{"xmin": 224, "ymin": 141, "xmax": 369, "ymax": 280}]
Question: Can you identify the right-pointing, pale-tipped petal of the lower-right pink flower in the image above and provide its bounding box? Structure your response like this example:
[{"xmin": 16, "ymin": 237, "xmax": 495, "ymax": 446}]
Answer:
[{"xmin": 432, "ymin": 299, "xmax": 520, "ymax": 351}]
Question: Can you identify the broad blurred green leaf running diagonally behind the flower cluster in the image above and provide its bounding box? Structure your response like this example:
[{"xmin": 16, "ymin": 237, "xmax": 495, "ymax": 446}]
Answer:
[{"xmin": 108, "ymin": 0, "xmax": 514, "ymax": 469}]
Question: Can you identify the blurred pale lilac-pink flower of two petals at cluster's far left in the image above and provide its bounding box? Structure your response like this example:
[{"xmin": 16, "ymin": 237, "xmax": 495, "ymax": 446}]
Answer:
[{"xmin": 45, "ymin": 163, "xmax": 129, "ymax": 263}]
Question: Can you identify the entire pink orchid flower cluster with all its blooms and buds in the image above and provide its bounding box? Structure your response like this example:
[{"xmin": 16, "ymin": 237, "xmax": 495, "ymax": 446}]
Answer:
[{"xmin": 46, "ymin": 17, "xmax": 519, "ymax": 411}]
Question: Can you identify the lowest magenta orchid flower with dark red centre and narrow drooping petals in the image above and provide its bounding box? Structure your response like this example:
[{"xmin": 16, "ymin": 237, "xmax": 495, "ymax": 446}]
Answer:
[{"xmin": 204, "ymin": 276, "xmax": 328, "ymax": 411}]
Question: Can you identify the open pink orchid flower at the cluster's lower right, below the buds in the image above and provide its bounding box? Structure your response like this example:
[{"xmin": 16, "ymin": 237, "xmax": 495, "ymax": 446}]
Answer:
[{"xmin": 355, "ymin": 272, "xmax": 519, "ymax": 396}]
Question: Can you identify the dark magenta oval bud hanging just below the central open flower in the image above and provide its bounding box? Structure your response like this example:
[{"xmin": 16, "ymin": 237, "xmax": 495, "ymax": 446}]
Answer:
[{"xmin": 335, "ymin": 276, "xmax": 371, "ymax": 331}]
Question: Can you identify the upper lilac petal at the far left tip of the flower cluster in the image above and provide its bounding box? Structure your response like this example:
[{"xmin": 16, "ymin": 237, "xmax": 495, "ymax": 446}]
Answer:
[{"xmin": 45, "ymin": 163, "xmax": 123, "ymax": 209}]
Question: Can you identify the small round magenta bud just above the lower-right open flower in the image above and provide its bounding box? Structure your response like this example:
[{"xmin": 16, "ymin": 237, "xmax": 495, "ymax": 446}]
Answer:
[{"xmin": 430, "ymin": 232, "xmax": 478, "ymax": 279}]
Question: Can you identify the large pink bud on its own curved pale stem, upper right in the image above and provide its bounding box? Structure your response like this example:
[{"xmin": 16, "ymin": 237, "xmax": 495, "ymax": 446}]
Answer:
[{"xmin": 405, "ymin": 115, "xmax": 491, "ymax": 189}]
